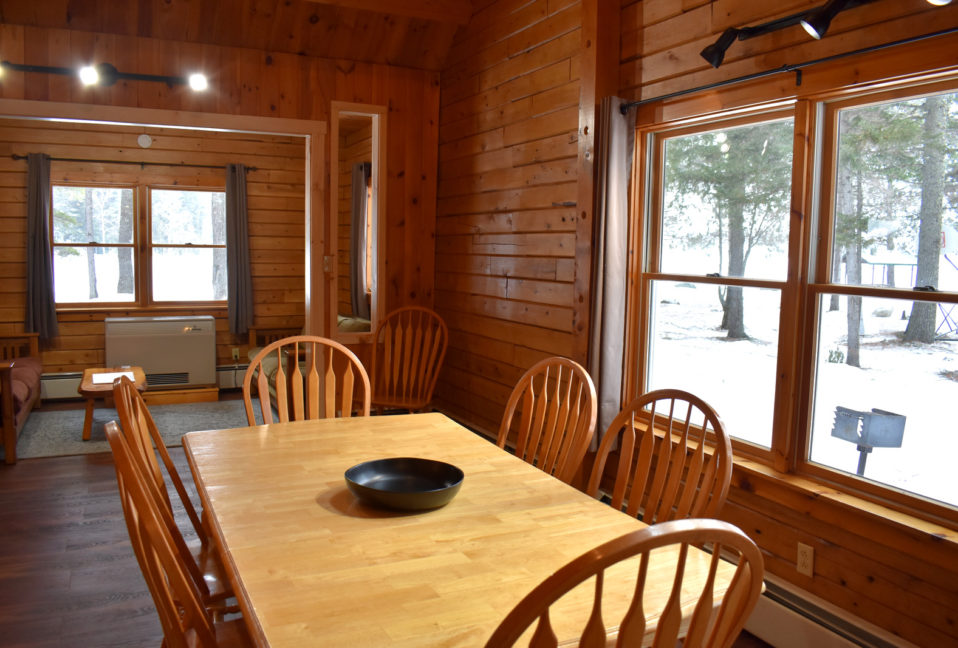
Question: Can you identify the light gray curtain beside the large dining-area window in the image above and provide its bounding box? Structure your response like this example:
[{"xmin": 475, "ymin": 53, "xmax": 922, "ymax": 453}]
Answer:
[{"xmin": 589, "ymin": 97, "xmax": 636, "ymax": 437}]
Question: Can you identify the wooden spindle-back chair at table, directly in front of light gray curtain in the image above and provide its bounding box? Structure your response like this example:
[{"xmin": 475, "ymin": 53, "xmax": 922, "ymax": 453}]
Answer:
[{"xmin": 496, "ymin": 357, "xmax": 598, "ymax": 483}]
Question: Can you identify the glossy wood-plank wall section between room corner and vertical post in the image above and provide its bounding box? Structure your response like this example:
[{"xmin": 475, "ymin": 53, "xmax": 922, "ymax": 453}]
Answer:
[{"xmin": 436, "ymin": 0, "xmax": 588, "ymax": 430}]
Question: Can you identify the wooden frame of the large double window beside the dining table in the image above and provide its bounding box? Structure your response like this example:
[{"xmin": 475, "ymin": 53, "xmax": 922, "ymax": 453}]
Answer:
[{"xmin": 625, "ymin": 75, "xmax": 958, "ymax": 528}]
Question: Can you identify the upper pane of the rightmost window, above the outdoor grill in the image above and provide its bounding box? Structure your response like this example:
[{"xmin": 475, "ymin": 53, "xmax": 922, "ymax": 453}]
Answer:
[{"xmin": 831, "ymin": 93, "xmax": 958, "ymax": 291}]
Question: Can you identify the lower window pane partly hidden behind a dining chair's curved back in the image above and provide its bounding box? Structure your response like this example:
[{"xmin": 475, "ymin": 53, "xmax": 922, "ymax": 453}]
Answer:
[{"xmin": 648, "ymin": 281, "xmax": 781, "ymax": 447}]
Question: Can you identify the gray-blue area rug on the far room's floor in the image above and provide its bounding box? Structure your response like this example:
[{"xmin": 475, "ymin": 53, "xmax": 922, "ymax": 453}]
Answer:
[{"xmin": 17, "ymin": 399, "xmax": 259, "ymax": 459}]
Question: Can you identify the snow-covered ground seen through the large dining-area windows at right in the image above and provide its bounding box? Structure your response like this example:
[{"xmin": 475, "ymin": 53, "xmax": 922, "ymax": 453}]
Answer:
[{"xmin": 649, "ymin": 282, "xmax": 958, "ymax": 504}]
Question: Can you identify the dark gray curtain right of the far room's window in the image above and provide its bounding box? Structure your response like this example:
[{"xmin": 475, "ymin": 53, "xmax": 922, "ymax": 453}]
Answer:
[{"xmin": 226, "ymin": 164, "xmax": 253, "ymax": 335}]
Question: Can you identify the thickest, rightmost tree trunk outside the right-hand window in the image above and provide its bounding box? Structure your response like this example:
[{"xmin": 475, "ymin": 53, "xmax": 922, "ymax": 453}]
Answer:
[{"xmin": 904, "ymin": 96, "xmax": 945, "ymax": 344}]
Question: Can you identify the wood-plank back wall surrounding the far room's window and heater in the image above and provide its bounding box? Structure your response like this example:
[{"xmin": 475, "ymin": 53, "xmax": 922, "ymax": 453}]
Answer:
[{"xmin": 0, "ymin": 120, "xmax": 306, "ymax": 372}]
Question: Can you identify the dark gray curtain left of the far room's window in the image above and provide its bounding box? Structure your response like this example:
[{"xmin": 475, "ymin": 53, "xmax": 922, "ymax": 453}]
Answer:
[{"xmin": 24, "ymin": 153, "xmax": 58, "ymax": 340}]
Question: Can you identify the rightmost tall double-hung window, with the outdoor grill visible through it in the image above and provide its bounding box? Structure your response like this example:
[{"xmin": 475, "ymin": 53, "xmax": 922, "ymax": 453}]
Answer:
[{"xmin": 809, "ymin": 92, "xmax": 958, "ymax": 505}]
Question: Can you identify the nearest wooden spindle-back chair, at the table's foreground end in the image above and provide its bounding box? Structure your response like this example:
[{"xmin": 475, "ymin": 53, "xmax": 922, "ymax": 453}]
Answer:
[{"xmin": 486, "ymin": 519, "xmax": 764, "ymax": 648}]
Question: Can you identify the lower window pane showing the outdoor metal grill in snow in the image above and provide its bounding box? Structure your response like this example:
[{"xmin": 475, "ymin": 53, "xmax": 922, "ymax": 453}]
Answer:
[{"xmin": 810, "ymin": 295, "xmax": 958, "ymax": 505}]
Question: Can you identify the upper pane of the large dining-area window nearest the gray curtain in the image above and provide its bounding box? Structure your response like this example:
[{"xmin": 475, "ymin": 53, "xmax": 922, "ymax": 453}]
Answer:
[{"xmin": 661, "ymin": 119, "xmax": 793, "ymax": 279}]
